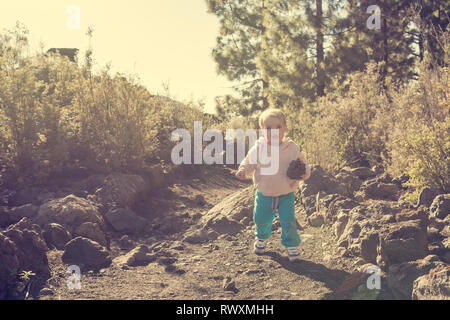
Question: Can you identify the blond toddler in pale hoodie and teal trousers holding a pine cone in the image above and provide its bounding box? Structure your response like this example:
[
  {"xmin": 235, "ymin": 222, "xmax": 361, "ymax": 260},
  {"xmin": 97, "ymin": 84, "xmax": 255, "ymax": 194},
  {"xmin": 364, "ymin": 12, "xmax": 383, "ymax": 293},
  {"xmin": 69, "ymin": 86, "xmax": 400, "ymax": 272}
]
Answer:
[{"xmin": 236, "ymin": 109, "xmax": 311, "ymax": 261}]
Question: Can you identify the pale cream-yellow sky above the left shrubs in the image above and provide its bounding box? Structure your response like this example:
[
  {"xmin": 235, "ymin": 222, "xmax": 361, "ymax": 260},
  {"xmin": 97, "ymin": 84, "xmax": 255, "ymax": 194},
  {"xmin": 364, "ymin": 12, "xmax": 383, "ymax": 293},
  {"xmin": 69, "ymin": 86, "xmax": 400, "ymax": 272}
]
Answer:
[{"xmin": 0, "ymin": 0, "xmax": 234, "ymax": 113}]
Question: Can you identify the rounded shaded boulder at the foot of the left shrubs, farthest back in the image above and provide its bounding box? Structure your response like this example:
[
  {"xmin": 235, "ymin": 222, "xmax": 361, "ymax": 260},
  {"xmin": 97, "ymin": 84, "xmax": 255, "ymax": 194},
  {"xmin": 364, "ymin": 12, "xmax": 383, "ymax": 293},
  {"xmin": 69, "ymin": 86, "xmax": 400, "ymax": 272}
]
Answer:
[{"xmin": 95, "ymin": 173, "xmax": 147, "ymax": 211}]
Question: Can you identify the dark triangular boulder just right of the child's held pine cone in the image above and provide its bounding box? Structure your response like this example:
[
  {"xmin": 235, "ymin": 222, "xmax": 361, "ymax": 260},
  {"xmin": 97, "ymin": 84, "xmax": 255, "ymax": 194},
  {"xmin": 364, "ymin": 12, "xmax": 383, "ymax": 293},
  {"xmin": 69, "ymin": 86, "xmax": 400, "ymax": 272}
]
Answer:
[{"xmin": 300, "ymin": 165, "xmax": 347, "ymax": 197}]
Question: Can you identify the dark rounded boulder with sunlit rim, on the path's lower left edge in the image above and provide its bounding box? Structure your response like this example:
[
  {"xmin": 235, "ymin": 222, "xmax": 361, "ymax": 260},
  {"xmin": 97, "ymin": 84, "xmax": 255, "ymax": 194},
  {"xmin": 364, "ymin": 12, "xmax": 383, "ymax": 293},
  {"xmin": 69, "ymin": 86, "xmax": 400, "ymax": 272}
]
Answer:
[{"xmin": 62, "ymin": 237, "xmax": 112, "ymax": 270}]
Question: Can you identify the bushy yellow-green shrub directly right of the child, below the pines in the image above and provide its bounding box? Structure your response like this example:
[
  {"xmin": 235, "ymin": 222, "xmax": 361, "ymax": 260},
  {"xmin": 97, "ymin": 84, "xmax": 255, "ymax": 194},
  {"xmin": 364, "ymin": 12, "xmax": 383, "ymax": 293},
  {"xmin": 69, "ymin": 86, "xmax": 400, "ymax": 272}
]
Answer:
[{"xmin": 289, "ymin": 63, "xmax": 389, "ymax": 170}]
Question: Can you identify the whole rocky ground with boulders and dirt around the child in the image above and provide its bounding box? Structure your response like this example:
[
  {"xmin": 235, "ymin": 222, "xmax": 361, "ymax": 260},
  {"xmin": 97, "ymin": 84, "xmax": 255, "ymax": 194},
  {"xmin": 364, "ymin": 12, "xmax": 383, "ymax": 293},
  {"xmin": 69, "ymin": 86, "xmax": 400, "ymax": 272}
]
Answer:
[{"xmin": 0, "ymin": 166, "xmax": 450, "ymax": 300}]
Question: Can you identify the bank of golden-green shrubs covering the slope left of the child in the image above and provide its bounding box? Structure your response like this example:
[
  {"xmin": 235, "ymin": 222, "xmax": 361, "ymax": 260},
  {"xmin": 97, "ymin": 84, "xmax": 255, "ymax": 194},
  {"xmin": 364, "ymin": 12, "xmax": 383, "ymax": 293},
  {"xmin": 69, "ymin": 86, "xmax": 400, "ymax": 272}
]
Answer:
[{"xmin": 0, "ymin": 24, "xmax": 218, "ymax": 187}]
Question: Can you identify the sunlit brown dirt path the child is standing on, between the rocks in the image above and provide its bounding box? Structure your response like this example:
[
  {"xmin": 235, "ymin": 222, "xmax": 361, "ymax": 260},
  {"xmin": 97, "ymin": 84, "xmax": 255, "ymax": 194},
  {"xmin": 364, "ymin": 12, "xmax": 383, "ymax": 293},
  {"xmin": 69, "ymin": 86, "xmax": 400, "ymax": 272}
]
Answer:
[{"xmin": 42, "ymin": 168, "xmax": 366, "ymax": 300}]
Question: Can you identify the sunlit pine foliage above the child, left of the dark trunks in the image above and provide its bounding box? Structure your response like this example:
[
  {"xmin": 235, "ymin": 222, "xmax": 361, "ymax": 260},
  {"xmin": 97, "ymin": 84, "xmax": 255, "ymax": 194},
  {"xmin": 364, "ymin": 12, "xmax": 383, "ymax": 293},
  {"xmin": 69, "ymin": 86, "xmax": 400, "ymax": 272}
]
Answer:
[{"xmin": 207, "ymin": 0, "xmax": 334, "ymax": 116}]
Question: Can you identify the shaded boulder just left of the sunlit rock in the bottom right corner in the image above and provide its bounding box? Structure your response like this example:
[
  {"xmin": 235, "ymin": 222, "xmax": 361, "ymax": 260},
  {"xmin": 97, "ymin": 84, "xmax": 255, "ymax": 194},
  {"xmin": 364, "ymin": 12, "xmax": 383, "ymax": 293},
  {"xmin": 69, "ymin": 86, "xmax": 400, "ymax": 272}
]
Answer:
[{"xmin": 387, "ymin": 255, "xmax": 442, "ymax": 300}]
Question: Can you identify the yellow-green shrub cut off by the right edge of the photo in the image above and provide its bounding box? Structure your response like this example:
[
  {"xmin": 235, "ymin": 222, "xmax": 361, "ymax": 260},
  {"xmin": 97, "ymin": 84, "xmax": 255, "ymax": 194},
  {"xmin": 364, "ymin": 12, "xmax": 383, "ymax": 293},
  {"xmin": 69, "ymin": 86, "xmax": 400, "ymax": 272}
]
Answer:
[{"xmin": 386, "ymin": 54, "xmax": 450, "ymax": 192}]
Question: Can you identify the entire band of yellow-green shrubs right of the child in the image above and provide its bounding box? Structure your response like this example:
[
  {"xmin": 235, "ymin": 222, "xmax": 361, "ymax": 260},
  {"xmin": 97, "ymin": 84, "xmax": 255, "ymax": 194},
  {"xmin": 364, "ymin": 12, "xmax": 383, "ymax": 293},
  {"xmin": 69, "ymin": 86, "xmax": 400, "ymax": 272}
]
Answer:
[{"xmin": 286, "ymin": 39, "xmax": 450, "ymax": 201}]
